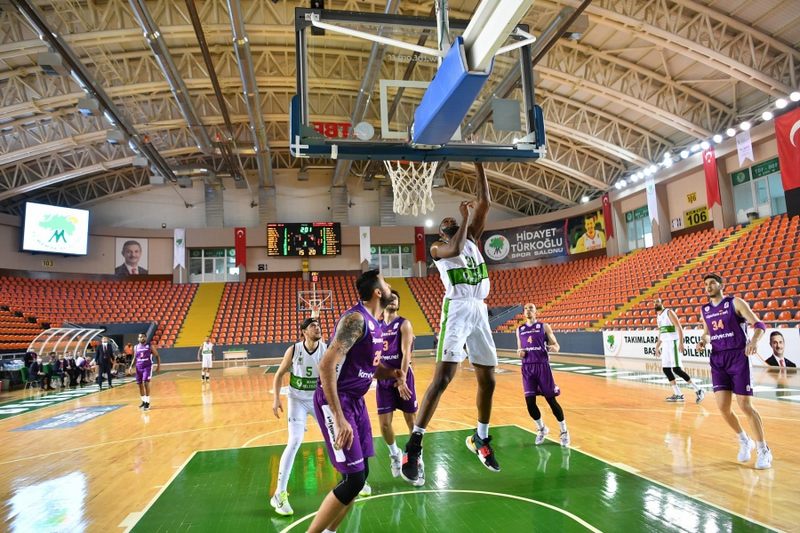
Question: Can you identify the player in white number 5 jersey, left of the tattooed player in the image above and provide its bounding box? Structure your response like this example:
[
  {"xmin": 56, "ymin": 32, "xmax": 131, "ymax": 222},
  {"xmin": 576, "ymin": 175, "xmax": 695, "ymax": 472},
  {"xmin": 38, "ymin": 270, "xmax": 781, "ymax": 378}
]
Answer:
[{"xmin": 269, "ymin": 318, "xmax": 327, "ymax": 516}]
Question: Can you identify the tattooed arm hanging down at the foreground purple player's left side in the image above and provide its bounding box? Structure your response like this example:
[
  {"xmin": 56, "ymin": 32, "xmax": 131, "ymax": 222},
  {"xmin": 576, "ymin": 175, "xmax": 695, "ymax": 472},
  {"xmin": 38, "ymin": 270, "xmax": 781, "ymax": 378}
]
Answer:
[{"xmin": 319, "ymin": 313, "xmax": 364, "ymax": 449}]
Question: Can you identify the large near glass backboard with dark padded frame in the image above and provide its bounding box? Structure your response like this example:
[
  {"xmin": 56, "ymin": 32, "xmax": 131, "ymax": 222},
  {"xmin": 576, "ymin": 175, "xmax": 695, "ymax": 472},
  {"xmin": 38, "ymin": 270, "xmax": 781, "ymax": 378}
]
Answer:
[{"xmin": 290, "ymin": 8, "xmax": 544, "ymax": 161}]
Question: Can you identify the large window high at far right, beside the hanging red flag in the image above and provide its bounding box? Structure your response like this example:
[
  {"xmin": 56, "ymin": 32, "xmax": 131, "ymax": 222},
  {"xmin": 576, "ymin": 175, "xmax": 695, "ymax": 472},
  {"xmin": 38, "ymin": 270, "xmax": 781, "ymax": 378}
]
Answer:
[{"xmin": 731, "ymin": 157, "xmax": 786, "ymax": 224}]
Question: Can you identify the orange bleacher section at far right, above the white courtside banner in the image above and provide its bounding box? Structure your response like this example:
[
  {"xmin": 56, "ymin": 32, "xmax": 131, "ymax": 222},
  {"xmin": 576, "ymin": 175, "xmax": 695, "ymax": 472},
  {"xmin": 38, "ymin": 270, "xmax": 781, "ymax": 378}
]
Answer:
[{"xmin": 607, "ymin": 215, "xmax": 800, "ymax": 329}]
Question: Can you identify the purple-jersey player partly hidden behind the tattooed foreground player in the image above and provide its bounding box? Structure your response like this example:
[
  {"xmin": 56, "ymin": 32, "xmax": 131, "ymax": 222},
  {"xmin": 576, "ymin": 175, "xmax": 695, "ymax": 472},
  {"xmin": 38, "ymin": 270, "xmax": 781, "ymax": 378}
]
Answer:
[{"xmin": 375, "ymin": 290, "xmax": 424, "ymax": 485}]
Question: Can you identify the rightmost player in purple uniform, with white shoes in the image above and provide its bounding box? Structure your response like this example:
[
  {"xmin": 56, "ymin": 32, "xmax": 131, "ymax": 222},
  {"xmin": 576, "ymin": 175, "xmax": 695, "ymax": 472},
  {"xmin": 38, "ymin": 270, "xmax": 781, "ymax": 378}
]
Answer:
[{"xmin": 697, "ymin": 274, "xmax": 772, "ymax": 469}]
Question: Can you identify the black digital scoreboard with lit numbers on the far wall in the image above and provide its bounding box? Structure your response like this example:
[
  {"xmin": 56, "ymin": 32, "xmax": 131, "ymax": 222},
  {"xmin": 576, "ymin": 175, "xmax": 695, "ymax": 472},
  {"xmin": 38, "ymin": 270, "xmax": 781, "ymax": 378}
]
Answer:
[{"xmin": 267, "ymin": 222, "xmax": 342, "ymax": 257}]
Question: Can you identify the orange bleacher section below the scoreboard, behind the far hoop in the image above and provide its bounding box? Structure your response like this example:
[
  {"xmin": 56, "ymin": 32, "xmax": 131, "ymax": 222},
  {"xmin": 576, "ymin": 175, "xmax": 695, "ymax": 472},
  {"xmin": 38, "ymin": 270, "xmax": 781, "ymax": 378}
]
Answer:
[{"xmin": 216, "ymin": 275, "xmax": 358, "ymax": 345}]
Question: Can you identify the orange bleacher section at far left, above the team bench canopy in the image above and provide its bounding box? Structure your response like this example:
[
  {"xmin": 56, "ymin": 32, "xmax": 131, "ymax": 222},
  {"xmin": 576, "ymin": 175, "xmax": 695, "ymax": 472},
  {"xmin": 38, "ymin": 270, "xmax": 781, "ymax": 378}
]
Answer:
[{"xmin": 0, "ymin": 276, "xmax": 197, "ymax": 347}]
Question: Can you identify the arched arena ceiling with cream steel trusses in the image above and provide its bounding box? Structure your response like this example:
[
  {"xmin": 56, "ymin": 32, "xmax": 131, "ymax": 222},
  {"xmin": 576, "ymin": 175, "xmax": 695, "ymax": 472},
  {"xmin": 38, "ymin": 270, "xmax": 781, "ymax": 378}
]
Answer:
[{"xmin": 0, "ymin": 0, "xmax": 800, "ymax": 215}]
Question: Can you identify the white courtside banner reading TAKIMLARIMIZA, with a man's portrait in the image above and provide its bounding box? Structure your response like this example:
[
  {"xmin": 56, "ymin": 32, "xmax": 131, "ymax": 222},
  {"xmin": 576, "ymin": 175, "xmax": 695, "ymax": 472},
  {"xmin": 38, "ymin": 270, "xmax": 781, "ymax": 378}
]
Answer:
[{"xmin": 603, "ymin": 328, "xmax": 800, "ymax": 366}]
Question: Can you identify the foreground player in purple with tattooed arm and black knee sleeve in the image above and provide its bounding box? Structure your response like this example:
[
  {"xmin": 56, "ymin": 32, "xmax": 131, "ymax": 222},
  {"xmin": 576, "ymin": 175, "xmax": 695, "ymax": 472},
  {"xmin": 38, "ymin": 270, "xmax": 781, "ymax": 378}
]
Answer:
[{"xmin": 308, "ymin": 270, "xmax": 405, "ymax": 533}]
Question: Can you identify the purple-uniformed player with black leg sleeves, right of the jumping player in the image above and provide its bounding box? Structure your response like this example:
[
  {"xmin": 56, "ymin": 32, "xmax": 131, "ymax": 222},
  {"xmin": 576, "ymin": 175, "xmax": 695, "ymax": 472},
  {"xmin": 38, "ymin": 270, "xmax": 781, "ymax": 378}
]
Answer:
[{"xmin": 517, "ymin": 304, "xmax": 569, "ymax": 446}]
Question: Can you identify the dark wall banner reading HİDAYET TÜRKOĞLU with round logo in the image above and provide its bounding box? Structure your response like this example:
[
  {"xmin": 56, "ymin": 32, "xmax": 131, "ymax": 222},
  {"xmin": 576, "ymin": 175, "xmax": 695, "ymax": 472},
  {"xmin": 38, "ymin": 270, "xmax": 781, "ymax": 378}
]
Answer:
[{"xmin": 481, "ymin": 220, "xmax": 567, "ymax": 265}]
